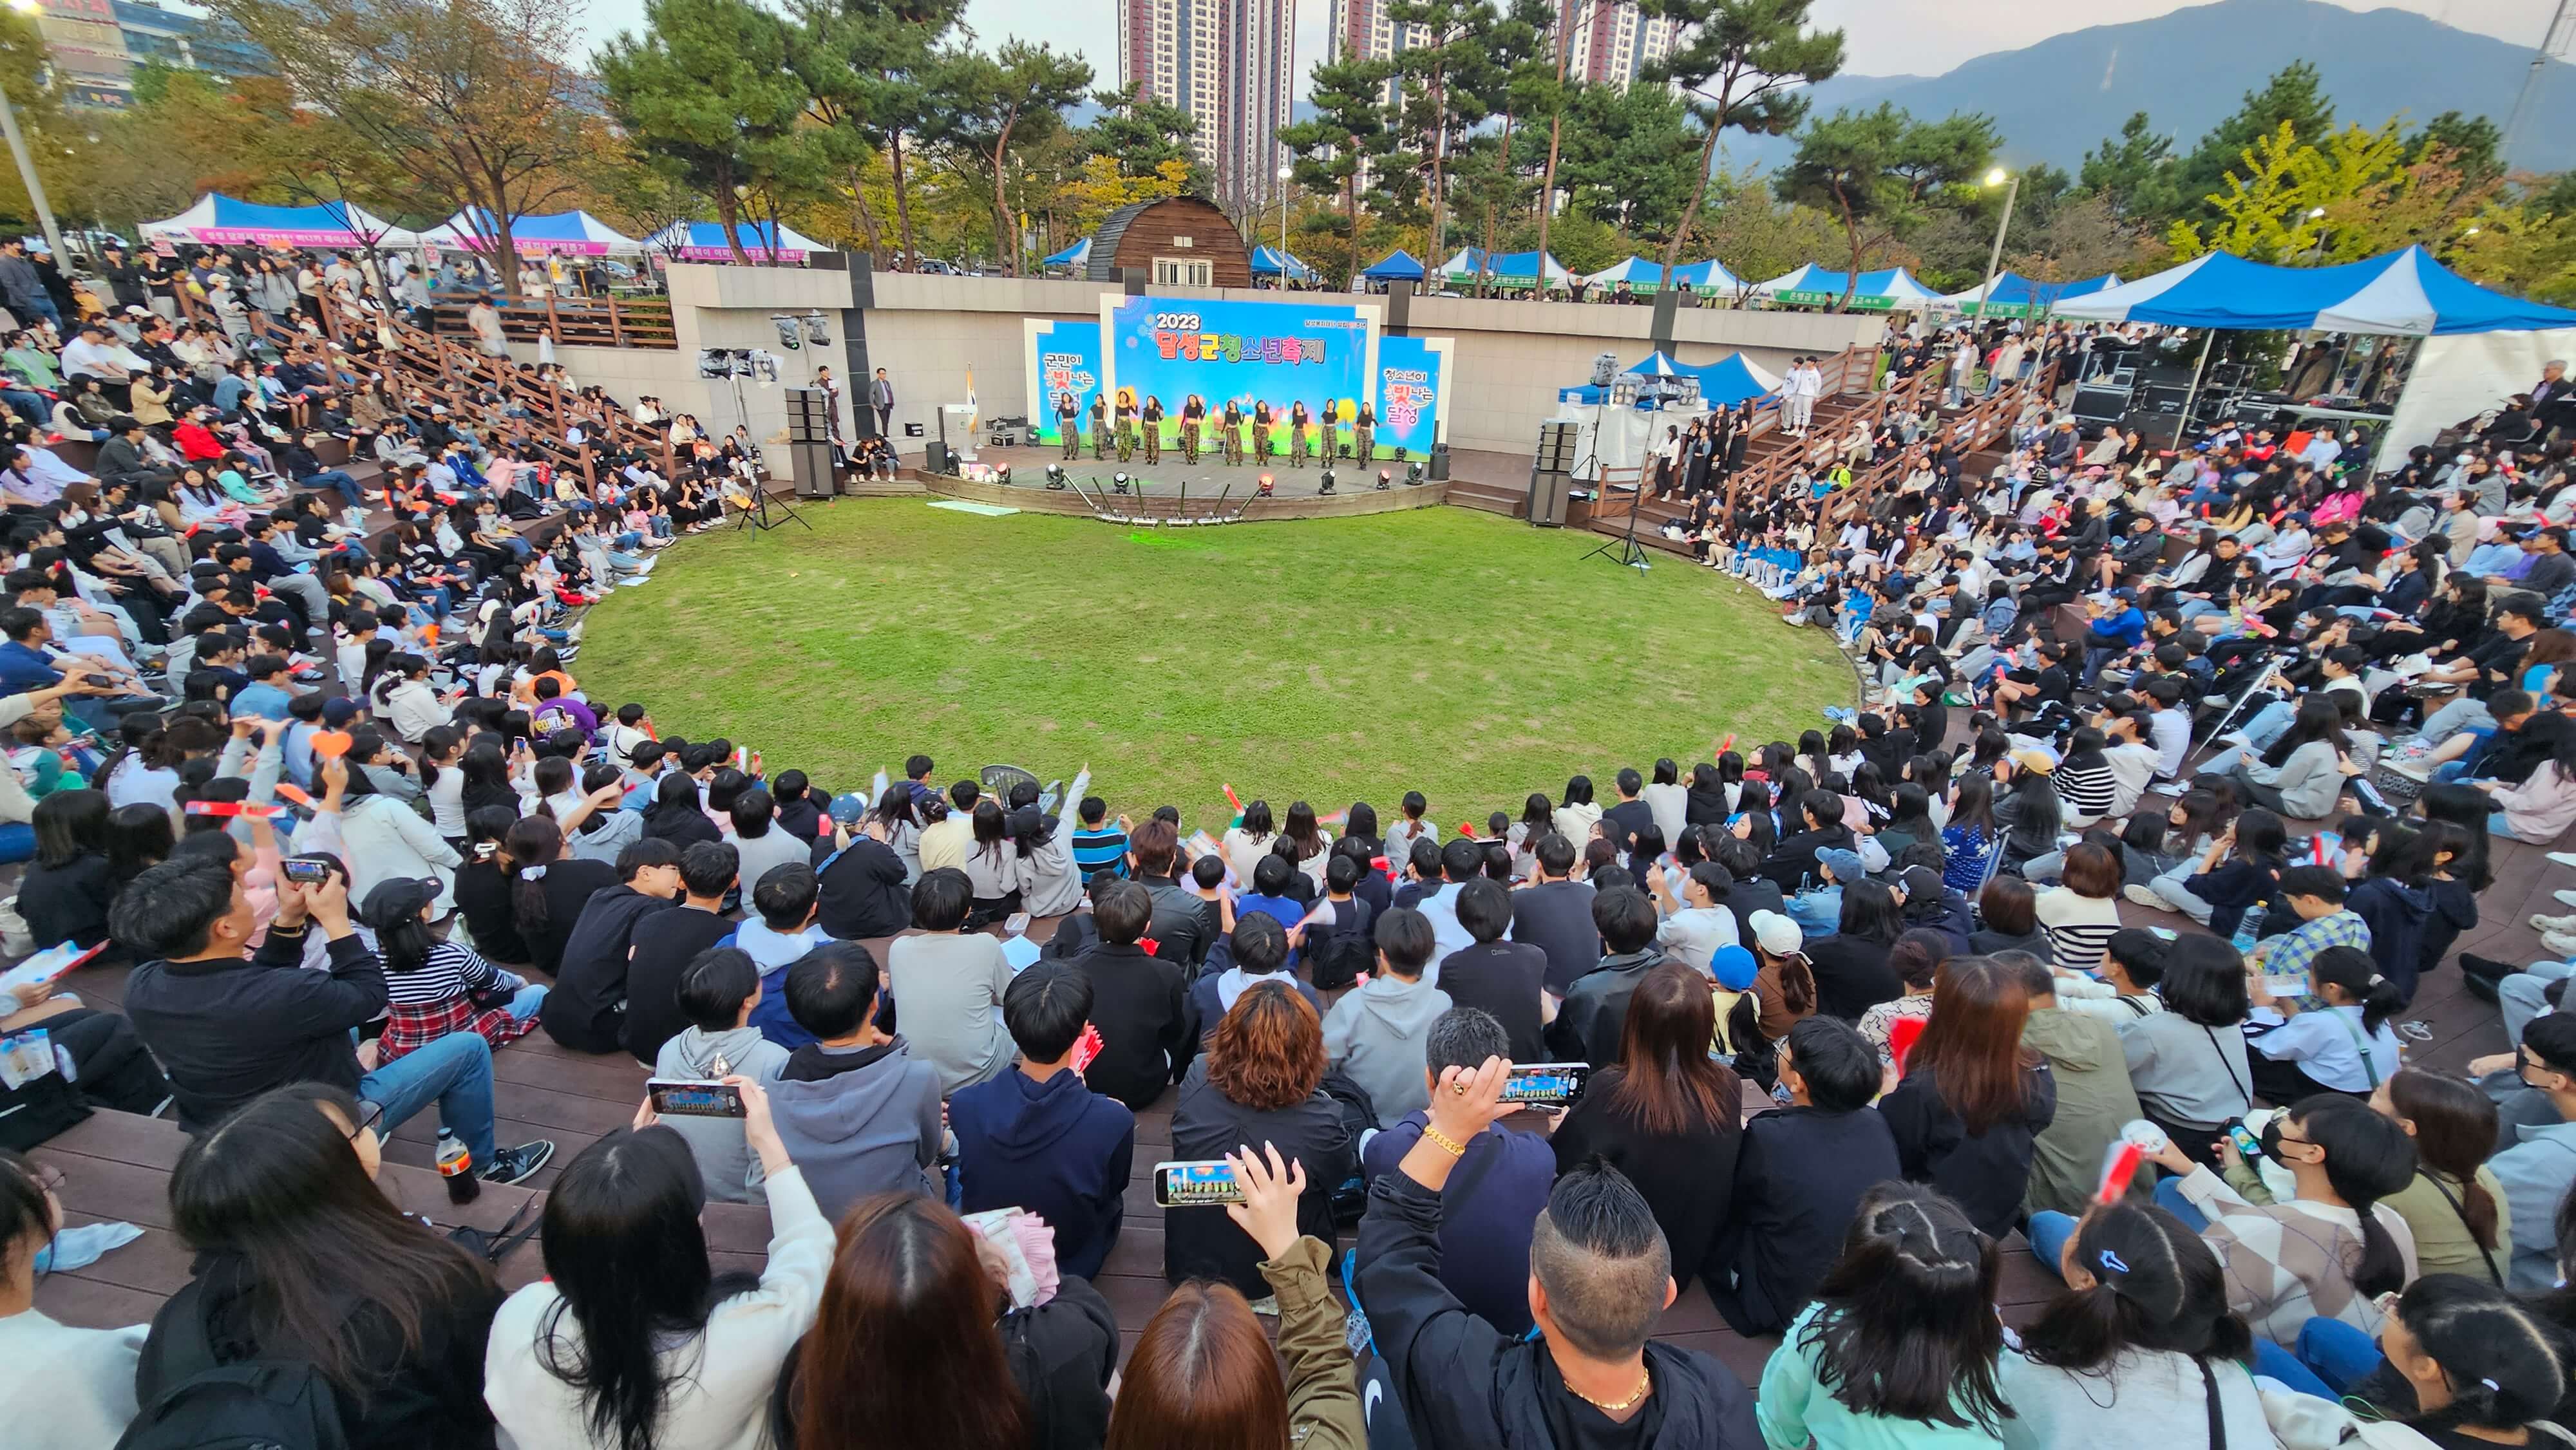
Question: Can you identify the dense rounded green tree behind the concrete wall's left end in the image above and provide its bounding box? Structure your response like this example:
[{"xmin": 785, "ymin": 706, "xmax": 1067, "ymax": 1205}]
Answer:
[{"xmin": 598, "ymin": 0, "xmax": 811, "ymax": 263}]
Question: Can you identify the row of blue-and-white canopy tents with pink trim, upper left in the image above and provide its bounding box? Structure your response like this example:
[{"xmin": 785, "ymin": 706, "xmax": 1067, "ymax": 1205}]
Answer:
[{"xmin": 142, "ymin": 191, "xmax": 824, "ymax": 263}]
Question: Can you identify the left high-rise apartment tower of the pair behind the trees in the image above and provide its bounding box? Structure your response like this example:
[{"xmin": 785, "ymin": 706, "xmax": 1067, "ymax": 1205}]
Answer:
[{"xmin": 1118, "ymin": 0, "xmax": 1296, "ymax": 209}]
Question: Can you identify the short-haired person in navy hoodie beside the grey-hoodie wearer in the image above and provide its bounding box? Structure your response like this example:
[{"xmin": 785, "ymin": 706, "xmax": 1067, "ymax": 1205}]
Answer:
[{"xmin": 948, "ymin": 961, "xmax": 1136, "ymax": 1283}]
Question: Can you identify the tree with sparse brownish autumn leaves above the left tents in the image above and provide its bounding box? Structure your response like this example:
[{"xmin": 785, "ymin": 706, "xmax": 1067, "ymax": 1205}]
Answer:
[{"xmin": 209, "ymin": 0, "xmax": 598, "ymax": 294}]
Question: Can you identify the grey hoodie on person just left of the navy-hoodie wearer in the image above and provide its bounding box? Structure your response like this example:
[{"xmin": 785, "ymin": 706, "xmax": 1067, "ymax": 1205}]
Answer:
[{"xmin": 770, "ymin": 1038, "xmax": 940, "ymax": 1221}]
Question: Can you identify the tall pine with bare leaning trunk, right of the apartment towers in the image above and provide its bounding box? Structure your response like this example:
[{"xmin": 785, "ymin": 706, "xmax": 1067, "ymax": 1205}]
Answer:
[{"xmin": 1641, "ymin": 0, "xmax": 1842, "ymax": 286}]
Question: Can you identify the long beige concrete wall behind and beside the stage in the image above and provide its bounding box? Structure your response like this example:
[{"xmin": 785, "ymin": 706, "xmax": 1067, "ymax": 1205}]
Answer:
[{"xmin": 492, "ymin": 265, "xmax": 1886, "ymax": 466}]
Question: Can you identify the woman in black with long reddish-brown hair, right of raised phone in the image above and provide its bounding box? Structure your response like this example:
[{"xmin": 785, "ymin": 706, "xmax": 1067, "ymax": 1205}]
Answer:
[{"xmin": 1553, "ymin": 961, "xmax": 1744, "ymax": 1285}]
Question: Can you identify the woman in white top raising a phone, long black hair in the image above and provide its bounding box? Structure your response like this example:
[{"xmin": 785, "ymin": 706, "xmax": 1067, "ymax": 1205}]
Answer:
[{"xmin": 484, "ymin": 1077, "xmax": 832, "ymax": 1450}]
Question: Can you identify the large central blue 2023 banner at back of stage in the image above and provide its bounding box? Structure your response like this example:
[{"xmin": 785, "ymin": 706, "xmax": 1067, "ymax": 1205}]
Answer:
[{"xmin": 1108, "ymin": 296, "xmax": 1370, "ymax": 451}]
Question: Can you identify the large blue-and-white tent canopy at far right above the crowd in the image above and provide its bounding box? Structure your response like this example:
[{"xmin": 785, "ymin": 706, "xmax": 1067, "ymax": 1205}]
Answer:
[{"xmin": 2056, "ymin": 247, "xmax": 2576, "ymax": 337}]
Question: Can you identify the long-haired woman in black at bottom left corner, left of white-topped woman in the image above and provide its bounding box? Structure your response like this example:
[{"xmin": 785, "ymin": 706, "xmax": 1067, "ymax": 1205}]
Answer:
[{"xmin": 134, "ymin": 1082, "xmax": 500, "ymax": 1447}]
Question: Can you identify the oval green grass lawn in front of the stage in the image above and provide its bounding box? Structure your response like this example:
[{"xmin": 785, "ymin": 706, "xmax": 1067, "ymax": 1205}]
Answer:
[{"xmin": 574, "ymin": 500, "xmax": 1852, "ymax": 827}]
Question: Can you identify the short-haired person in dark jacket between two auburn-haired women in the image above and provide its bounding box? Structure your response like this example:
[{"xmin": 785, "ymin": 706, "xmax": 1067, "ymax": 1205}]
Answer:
[{"xmin": 1708, "ymin": 1017, "xmax": 1904, "ymax": 1334}]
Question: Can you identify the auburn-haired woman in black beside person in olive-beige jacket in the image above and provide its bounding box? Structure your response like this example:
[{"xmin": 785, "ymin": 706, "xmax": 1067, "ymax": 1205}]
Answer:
[{"xmin": 1878, "ymin": 956, "xmax": 2058, "ymax": 1236}]
